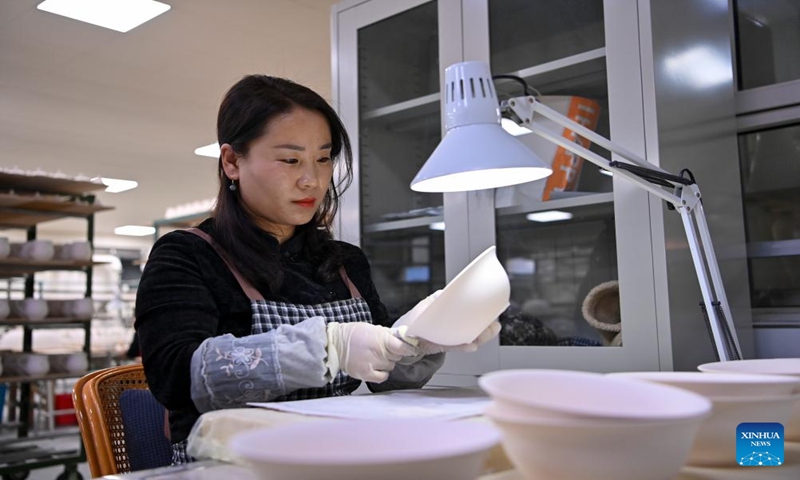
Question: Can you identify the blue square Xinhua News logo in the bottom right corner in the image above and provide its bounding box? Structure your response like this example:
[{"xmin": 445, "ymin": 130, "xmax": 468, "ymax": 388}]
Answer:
[{"xmin": 736, "ymin": 423, "xmax": 783, "ymax": 467}]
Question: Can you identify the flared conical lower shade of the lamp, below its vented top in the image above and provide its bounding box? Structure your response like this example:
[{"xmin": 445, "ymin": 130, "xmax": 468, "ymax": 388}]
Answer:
[{"xmin": 411, "ymin": 123, "xmax": 553, "ymax": 192}]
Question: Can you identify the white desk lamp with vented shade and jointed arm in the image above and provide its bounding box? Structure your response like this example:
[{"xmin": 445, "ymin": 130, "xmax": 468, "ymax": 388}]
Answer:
[{"xmin": 411, "ymin": 61, "xmax": 742, "ymax": 361}]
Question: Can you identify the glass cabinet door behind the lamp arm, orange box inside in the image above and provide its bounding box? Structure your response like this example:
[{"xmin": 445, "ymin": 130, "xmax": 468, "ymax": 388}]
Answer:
[{"xmin": 488, "ymin": 0, "xmax": 622, "ymax": 350}]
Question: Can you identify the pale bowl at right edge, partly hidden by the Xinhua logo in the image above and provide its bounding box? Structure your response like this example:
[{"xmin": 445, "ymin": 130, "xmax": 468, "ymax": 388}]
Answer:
[{"xmin": 610, "ymin": 372, "xmax": 800, "ymax": 467}]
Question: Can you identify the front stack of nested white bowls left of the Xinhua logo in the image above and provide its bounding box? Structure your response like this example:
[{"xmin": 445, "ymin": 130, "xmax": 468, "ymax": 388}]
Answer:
[{"xmin": 479, "ymin": 370, "xmax": 711, "ymax": 480}]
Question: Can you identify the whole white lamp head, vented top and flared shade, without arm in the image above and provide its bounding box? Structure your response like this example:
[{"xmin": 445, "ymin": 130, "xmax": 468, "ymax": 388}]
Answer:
[{"xmin": 411, "ymin": 62, "xmax": 553, "ymax": 192}]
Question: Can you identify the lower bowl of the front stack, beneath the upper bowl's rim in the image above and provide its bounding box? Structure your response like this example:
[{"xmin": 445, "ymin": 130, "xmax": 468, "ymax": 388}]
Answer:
[{"xmin": 486, "ymin": 406, "xmax": 702, "ymax": 480}]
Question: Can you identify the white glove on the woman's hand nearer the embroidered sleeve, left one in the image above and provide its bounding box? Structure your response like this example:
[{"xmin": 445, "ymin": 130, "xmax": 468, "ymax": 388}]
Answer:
[{"xmin": 326, "ymin": 322, "xmax": 417, "ymax": 383}]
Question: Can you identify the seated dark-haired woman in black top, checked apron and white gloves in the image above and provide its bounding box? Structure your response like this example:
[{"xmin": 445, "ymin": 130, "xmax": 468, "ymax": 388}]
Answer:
[{"xmin": 136, "ymin": 75, "xmax": 498, "ymax": 463}]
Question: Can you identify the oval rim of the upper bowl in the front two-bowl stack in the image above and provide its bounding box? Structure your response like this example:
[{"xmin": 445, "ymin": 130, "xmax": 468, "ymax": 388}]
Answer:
[{"xmin": 478, "ymin": 369, "xmax": 711, "ymax": 420}]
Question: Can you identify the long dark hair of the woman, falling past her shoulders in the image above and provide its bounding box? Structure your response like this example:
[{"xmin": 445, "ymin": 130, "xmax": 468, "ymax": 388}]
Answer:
[{"xmin": 213, "ymin": 75, "xmax": 353, "ymax": 295}]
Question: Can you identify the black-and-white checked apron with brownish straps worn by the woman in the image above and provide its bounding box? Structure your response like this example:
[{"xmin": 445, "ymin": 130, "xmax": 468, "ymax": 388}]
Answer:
[{"xmin": 186, "ymin": 228, "xmax": 372, "ymax": 402}]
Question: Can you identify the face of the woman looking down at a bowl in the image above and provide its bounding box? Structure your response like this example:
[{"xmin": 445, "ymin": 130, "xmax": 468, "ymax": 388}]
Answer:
[{"xmin": 223, "ymin": 107, "xmax": 333, "ymax": 242}]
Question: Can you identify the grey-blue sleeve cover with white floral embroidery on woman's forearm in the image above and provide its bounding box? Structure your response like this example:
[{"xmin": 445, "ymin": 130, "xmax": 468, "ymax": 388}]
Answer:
[{"xmin": 191, "ymin": 317, "xmax": 327, "ymax": 413}]
